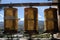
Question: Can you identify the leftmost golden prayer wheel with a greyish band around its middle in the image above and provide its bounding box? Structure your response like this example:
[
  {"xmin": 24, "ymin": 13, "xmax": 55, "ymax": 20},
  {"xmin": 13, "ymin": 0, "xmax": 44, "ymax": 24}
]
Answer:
[{"xmin": 4, "ymin": 8, "xmax": 18, "ymax": 33}]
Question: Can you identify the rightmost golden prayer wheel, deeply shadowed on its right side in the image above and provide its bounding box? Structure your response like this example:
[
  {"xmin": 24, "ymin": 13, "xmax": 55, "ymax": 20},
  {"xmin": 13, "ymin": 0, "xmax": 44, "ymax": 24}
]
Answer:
[{"xmin": 44, "ymin": 8, "xmax": 58, "ymax": 33}]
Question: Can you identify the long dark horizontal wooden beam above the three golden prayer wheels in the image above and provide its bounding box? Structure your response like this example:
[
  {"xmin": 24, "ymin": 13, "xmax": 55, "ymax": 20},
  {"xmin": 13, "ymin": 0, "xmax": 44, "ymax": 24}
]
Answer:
[{"xmin": 0, "ymin": 3, "xmax": 59, "ymax": 7}]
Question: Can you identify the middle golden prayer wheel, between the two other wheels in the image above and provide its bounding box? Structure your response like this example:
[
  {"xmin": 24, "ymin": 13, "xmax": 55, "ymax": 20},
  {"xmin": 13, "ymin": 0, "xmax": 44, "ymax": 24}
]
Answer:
[{"xmin": 24, "ymin": 8, "xmax": 38, "ymax": 33}]
